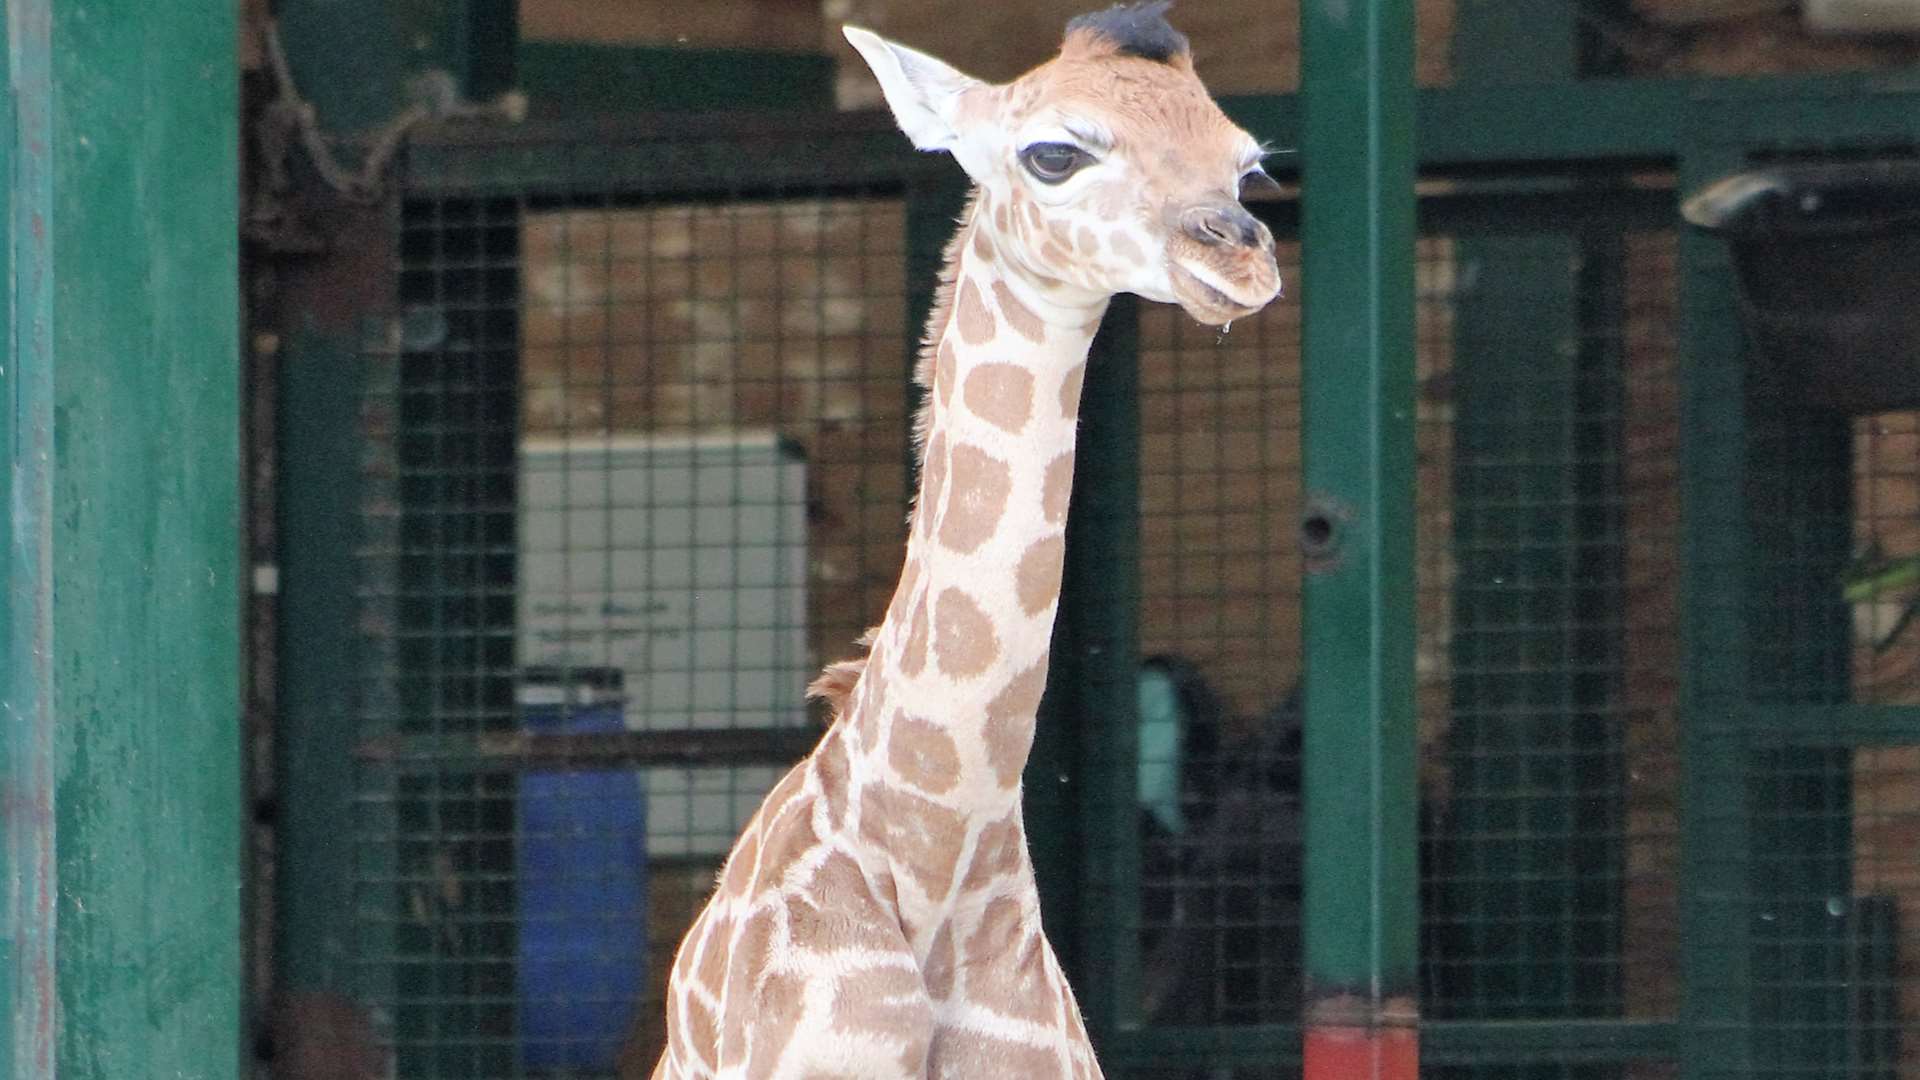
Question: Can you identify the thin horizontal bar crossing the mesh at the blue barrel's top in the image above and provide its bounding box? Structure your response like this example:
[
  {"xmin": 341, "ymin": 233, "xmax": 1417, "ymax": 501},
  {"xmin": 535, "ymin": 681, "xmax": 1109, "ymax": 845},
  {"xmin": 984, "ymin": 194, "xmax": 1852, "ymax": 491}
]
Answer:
[{"xmin": 353, "ymin": 728, "xmax": 820, "ymax": 773}]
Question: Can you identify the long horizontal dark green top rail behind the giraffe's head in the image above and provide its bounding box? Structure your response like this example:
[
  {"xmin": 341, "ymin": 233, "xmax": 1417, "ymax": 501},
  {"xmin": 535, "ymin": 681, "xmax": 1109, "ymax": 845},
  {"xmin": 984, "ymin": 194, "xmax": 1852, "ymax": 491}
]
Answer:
[{"xmin": 397, "ymin": 75, "xmax": 1920, "ymax": 196}]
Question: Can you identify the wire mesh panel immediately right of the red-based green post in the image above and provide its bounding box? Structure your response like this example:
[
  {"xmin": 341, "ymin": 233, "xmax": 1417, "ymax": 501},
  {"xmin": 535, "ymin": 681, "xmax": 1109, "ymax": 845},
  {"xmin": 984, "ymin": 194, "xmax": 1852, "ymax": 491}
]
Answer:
[{"xmin": 1421, "ymin": 229, "xmax": 1680, "ymax": 1020}]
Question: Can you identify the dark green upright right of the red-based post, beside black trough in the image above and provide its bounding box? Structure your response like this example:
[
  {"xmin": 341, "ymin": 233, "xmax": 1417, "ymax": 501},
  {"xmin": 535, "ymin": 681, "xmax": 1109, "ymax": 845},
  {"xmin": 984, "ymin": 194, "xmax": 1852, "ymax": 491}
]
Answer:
[{"xmin": 1680, "ymin": 148, "xmax": 1759, "ymax": 1080}]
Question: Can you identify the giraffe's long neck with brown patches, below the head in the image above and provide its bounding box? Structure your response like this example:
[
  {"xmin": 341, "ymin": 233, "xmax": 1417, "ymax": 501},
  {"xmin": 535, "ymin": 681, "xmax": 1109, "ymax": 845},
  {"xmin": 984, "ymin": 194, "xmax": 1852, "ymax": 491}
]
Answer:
[{"xmin": 843, "ymin": 187, "xmax": 1108, "ymax": 905}]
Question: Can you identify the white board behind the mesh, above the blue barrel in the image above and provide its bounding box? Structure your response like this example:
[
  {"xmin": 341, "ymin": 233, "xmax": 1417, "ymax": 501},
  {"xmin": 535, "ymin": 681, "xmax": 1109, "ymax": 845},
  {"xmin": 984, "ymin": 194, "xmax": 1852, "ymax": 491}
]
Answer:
[{"xmin": 518, "ymin": 432, "xmax": 812, "ymax": 855}]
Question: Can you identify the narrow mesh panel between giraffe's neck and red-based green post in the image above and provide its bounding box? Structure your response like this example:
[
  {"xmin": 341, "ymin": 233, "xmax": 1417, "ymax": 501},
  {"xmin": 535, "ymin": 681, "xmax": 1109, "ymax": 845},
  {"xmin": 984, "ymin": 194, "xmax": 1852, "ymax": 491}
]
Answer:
[{"xmin": 1139, "ymin": 242, "xmax": 1302, "ymax": 1024}]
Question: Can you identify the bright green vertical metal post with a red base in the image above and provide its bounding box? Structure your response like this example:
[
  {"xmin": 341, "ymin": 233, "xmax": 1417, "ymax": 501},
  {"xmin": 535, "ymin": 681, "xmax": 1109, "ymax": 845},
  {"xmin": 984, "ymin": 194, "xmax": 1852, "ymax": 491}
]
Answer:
[{"xmin": 1300, "ymin": 0, "xmax": 1419, "ymax": 1080}]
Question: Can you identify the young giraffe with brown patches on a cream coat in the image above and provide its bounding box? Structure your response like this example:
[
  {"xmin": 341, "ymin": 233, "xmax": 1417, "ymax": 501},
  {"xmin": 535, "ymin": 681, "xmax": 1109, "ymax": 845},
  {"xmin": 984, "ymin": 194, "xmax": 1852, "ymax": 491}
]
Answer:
[{"xmin": 655, "ymin": 4, "xmax": 1279, "ymax": 1080}]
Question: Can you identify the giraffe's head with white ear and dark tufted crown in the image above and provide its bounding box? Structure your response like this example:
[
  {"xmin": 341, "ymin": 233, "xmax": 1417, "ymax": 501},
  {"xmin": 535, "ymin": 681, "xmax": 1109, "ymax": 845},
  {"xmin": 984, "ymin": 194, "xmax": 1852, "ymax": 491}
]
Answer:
[{"xmin": 845, "ymin": 0, "xmax": 1281, "ymax": 325}]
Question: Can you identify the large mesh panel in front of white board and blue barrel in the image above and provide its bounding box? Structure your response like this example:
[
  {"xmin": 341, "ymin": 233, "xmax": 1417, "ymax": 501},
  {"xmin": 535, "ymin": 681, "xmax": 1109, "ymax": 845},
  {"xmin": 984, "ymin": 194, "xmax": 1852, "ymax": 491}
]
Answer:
[{"xmin": 351, "ymin": 135, "xmax": 910, "ymax": 1078}]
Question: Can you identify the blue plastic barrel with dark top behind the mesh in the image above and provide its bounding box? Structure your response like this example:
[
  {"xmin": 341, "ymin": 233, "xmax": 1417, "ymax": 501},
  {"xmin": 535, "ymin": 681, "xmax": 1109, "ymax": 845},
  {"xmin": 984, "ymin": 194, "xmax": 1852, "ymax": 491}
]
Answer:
[{"xmin": 516, "ymin": 671, "xmax": 647, "ymax": 1074}]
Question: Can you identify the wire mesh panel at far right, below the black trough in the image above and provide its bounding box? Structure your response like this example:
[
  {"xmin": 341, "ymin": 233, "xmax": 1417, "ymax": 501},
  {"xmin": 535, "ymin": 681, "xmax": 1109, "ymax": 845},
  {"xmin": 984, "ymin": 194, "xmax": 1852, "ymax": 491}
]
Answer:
[{"xmin": 1736, "ymin": 380, "xmax": 1920, "ymax": 1078}]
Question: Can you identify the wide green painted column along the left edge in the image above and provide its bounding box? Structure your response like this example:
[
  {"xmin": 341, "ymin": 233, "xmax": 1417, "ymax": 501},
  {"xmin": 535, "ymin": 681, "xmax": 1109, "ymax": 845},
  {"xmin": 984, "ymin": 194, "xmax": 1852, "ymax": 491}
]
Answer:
[{"xmin": 0, "ymin": 0, "xmax": 242, "ymax": 1078}]
